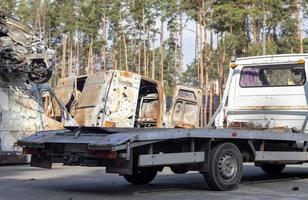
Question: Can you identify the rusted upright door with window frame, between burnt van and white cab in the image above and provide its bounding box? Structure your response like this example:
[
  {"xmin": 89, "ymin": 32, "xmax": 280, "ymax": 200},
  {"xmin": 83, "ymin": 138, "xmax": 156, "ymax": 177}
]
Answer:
[{"xmin": 170, "ymin": 85, "xmax": 202, "ymax": 128}]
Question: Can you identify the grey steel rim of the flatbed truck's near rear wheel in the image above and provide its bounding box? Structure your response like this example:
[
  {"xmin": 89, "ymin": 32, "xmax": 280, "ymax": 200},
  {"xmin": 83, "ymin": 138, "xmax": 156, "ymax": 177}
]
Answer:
[{"xmin": 218, "ymin": 154, "xmax": 237, "ymax": 180}]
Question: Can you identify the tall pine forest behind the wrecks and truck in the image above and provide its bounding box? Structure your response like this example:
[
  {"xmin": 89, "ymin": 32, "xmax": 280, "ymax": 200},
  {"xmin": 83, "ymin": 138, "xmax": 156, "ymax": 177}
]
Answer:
[{"xmin": 0, "ymin": 0, "xmax": 308, "ymax": 118}]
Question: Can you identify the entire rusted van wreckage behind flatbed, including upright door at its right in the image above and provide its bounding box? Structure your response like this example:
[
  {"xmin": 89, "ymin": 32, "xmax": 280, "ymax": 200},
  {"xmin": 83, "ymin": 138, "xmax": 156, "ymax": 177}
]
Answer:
[{"xmin": 56, "ymin": 70, "xmax": 202, "ymax": 128}]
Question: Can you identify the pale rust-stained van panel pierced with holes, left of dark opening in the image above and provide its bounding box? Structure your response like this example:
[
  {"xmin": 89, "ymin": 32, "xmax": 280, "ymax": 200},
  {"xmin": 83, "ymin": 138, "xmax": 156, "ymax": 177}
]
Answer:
[{"xmin": 75, "ymin": 70, "xmax": 141, "ymax": 127}]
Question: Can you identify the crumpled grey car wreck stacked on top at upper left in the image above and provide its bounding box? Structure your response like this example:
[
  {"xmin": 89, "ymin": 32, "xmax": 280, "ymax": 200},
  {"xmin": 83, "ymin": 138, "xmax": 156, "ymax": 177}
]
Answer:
[{"xmin": 0, "ymin": 12, "xmax": 54, "ymax": 83}]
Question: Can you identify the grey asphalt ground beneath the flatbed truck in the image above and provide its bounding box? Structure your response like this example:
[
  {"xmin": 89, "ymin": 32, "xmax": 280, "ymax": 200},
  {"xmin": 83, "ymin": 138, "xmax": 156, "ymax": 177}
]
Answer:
[{"xmin": 0, "ymin": 164, "xmax": 308, "ymax": 200}]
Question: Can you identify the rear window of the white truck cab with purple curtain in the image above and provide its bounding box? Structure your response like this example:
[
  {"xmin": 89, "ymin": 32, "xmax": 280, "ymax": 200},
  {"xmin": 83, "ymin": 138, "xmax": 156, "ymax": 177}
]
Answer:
[{"xmin": 240, "ymin": 64, "xmax": 306, "ymax": 88}]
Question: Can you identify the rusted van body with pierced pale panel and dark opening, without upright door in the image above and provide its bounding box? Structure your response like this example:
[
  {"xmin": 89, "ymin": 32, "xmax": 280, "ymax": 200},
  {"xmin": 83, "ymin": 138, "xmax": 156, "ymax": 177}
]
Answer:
[{"xmin": 75, "ymin": 70, "xmax": 164, "ymax": 127}]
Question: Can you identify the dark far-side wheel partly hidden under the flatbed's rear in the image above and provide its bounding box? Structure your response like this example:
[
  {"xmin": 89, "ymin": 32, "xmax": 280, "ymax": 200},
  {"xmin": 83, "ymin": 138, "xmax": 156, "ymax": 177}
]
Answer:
[{"xmin": 123, "ymin": 168, "xmax": 157, "ymax": 185}]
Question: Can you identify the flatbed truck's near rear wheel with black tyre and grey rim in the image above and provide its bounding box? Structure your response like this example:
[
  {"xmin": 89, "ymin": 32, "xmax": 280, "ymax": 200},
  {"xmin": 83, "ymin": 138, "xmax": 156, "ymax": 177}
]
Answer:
[{"xmin": 204, "ymin": 143, "xmax": 243, "ymax": 191}]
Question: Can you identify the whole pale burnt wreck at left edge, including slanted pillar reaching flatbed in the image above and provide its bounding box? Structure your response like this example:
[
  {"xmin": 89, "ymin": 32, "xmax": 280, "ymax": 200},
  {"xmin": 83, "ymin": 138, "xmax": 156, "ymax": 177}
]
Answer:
[{"xmin": 0, "ymin": 74, "xmax": 75, "ymax": 164}]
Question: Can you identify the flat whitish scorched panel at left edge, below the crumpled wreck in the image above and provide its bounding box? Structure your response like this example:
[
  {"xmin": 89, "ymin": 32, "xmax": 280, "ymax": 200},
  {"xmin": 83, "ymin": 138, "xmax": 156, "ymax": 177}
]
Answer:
[{"xmin": 0, "ymin": 74, "xmax": 44, "ymax": 151}]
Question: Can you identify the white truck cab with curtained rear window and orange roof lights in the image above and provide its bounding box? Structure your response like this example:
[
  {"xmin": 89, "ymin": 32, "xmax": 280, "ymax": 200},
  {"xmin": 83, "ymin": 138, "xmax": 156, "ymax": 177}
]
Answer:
[{"xmin": 215, "ymin": 54, "xmax": 308, "ymax": 132}]
